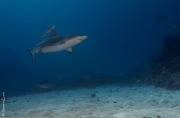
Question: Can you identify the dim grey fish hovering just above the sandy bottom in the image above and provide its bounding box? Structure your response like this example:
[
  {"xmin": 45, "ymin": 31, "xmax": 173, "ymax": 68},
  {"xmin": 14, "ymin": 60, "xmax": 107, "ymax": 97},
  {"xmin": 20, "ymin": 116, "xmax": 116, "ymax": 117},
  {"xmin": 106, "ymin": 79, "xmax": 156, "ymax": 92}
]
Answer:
[{"xmin": 35, "ymin": 80, "xmax": 53, "ymax": 89}]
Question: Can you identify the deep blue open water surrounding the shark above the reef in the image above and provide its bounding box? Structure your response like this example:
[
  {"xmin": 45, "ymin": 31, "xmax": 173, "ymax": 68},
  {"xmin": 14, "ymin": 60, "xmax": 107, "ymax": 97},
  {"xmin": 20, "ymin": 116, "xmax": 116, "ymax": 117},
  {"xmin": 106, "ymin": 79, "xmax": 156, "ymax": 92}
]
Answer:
[{"xmin": 0, "ymin": 0, "xmax": 180, "ymax": 95}]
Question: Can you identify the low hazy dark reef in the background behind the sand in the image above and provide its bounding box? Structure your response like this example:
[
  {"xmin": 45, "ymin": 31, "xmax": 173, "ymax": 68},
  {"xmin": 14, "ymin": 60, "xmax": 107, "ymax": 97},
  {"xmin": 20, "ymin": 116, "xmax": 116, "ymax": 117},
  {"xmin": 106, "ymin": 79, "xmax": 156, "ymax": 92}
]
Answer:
[{"xmin": 54, "ymin": 72, "xmax": 122, "ymax": 89}]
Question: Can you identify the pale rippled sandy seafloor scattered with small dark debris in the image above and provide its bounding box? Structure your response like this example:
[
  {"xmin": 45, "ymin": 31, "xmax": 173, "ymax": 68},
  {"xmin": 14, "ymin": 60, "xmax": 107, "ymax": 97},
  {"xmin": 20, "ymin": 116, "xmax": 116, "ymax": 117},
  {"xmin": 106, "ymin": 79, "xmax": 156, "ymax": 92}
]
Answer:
[{"xmin": 0, "ymin": 85, "xmax": 180, "ymax": 118}]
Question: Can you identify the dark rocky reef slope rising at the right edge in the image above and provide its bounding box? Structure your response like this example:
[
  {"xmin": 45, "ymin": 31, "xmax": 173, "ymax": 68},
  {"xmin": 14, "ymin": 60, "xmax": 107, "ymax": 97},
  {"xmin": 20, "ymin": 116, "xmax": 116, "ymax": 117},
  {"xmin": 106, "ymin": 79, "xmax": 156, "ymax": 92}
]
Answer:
[{"xmin": 123, "ymin": 34, "xmax": 180, "ymax": 90}]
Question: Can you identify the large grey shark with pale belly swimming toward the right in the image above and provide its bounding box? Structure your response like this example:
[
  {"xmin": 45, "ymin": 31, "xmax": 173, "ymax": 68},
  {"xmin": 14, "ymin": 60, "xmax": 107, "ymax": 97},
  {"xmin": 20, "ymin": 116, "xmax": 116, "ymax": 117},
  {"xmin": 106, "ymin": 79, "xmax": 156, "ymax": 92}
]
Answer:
[{"xmin": 27, "ymin": 29, "xmax": 87, "ymax": 62}]
